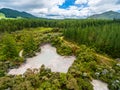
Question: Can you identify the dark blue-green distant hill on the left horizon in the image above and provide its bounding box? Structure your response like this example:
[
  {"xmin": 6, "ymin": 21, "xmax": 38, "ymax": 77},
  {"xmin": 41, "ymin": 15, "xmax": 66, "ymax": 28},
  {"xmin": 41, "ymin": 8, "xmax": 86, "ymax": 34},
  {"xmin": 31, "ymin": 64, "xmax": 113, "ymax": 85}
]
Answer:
[{"xmin": 0, "ymin": 8, "xmax": 37, "ymax": 18}]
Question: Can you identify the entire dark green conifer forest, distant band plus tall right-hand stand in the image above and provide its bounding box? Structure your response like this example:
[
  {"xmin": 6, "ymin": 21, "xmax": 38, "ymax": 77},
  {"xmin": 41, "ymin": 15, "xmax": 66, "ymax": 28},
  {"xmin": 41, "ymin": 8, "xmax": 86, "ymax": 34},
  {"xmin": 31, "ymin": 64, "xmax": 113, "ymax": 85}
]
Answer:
[{"xmin": 0, "ymin": 19, "xmax": 120, "ymax": 58}]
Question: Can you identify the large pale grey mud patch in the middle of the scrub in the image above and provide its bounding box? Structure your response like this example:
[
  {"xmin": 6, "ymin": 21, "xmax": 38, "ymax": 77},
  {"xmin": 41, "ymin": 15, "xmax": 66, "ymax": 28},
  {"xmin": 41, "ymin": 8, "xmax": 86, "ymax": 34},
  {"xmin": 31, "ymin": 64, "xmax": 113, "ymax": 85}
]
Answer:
[{"xmin": 8, "ymin": 44, "xmax": 76, "ymax": 75}]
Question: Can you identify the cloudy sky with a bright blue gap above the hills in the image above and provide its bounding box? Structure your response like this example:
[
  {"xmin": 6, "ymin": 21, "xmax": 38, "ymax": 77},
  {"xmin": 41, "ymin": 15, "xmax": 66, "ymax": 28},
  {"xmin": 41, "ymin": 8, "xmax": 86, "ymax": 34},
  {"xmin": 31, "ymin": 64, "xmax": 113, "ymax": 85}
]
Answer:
[{"xmin": 0, "ymin": 0, "xmax": 120, "ymax": 18}]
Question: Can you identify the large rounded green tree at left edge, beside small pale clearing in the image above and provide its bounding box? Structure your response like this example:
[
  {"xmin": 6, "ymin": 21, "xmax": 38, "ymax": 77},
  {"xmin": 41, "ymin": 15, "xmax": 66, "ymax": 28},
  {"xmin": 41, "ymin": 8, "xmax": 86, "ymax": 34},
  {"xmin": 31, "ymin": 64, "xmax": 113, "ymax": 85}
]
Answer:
[{"xmin": 1, "ymin": 34, "xmax": 18, "ymax": 60}]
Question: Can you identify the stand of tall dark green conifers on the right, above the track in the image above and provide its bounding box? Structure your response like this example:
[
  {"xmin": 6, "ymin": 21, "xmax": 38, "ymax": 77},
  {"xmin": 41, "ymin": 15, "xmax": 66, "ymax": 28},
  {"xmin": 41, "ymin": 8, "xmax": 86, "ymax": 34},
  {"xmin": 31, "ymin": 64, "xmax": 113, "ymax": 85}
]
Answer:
[{"xmin": 64, "ymin": 21, "xmax": 120, "ymax": 57}]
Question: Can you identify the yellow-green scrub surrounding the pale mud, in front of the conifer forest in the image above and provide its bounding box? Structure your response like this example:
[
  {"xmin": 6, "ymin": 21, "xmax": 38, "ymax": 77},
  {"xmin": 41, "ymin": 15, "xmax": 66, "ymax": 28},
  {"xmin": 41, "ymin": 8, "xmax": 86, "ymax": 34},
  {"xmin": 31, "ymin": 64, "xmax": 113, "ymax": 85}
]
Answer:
[{"xmin": 0, "ymin": 27, "xmax": 120, "ymax": 90}]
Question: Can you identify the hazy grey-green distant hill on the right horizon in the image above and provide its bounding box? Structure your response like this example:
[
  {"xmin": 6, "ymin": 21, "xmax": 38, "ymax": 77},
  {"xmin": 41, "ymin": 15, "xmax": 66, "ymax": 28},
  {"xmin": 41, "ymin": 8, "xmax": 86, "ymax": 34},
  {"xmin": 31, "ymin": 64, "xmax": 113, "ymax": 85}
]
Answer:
[{"xmin": 88, "ymin": 11, "xmax": 120, "ymax": 19}]
